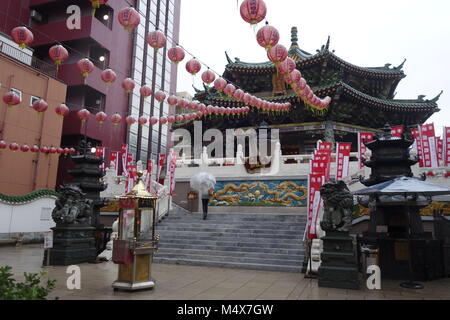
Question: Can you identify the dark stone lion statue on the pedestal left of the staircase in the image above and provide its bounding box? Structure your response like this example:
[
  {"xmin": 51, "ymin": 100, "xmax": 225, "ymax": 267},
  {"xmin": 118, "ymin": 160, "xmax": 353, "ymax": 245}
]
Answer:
[{"xmin": 52, "ymin": 185, "xmax": 94, "ymax": 225}]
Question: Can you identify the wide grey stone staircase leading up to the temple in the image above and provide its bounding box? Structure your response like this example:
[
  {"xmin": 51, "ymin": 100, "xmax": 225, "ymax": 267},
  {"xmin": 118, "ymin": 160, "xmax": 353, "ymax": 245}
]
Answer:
[{"xmin": 153, "ymin": 209, "xmax": 306, "ymax": 272}]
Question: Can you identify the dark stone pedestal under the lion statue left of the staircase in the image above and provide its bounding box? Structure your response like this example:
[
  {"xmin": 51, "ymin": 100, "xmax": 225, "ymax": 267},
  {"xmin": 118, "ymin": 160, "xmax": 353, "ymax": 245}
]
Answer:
[{"xmin": 44, "ymin": 226, "xmax": 97, "ymax": 266}]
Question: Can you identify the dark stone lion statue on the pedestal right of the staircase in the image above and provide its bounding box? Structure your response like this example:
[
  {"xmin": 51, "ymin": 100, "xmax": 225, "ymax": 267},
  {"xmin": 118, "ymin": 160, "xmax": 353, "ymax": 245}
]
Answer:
[{"xmin": 320, "ymin": 180, "xmax": 353, "ymax": 232}]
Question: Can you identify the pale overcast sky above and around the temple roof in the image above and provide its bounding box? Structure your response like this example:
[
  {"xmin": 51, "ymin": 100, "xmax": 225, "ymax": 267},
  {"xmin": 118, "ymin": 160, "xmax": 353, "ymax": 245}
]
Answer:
[{"xmin": 178, "ymin": 0, "xmax": 450, "ymax": 135}]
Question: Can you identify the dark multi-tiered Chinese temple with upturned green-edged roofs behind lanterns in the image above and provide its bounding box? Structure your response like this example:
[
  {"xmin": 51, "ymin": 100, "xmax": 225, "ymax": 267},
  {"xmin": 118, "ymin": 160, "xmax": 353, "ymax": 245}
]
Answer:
[{"xmin": 178, "ymin": 27, "xmax": 440, "ymax": 155}]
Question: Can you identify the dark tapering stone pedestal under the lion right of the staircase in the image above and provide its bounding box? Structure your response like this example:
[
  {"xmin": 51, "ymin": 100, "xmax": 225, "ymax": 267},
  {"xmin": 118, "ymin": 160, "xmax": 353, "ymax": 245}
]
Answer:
[{"xmin": 319, "ymin": 231, "xmax": 360, "ymax": 290}]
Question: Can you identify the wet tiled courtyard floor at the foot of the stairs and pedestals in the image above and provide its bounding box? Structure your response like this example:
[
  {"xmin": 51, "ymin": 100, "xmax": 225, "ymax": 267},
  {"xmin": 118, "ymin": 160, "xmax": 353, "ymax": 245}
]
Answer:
[{"xmin": 0, "ymin": 245, "xmax": 450, "ymax": 300}]
